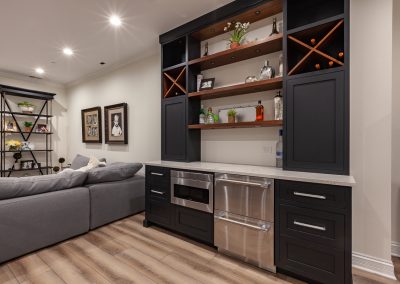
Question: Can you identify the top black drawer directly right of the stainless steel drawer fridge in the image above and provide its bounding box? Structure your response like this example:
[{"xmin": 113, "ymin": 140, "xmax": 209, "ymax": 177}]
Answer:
[{"xmin": 277, "ymin": 180, "xmax": 351, "ymax": 211}]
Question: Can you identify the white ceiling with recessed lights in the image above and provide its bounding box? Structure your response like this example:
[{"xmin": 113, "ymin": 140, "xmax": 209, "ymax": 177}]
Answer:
[{"xmin": 0, "ymin": 0, "xmax": 232, "ymax": 84}]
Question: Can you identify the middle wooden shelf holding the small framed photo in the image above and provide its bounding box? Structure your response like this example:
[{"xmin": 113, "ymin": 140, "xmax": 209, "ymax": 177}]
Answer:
[{"xmin": 188, "ymin": 77, "xmax": 283, "ymax": 99}]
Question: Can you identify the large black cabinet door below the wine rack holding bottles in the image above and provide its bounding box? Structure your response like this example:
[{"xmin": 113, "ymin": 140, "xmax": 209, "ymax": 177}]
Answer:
[{"xmin": 284, "ymin": 71, "xmax": 349, "ymax": 174}]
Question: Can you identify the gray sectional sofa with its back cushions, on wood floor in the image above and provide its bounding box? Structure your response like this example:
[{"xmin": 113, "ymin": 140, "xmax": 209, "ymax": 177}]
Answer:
[{"xmin": 0, "ymin": 163, "xmax": 145, "ymax": 263}]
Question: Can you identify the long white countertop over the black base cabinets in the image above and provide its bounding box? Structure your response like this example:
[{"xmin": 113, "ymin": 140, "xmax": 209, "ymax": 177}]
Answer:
[{"xmin": 144, "ymin": 161, "xmax": 356, "ymax": 187}]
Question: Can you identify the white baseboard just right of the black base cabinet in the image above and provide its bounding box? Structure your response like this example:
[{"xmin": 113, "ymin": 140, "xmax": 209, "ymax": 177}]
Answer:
[{"xmin": 352, "ymin": 252, "xmax": 396, "ymax": 280}]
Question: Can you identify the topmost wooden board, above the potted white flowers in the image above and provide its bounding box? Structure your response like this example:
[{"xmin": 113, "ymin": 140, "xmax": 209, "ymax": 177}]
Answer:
[{"xmin": 192, "ymin": 0, "xmax": 283, "ymax": 41}]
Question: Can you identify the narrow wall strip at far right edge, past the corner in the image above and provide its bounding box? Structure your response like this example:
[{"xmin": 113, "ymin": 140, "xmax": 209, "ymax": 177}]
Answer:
[{"xmin": 392, "ymin": 0, "xmax": 400, "ymax": 244}]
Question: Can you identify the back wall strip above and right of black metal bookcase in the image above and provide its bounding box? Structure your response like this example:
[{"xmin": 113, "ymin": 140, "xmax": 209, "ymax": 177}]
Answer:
[{"xmin": 0, "ymin": 73, "xmax": 68, "ymax": 165}]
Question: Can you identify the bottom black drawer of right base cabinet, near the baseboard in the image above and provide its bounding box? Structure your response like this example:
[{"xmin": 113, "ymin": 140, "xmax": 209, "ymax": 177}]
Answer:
[{"xmin": 278, "ymin": 237, "xmax": 345, "ymax": 284}]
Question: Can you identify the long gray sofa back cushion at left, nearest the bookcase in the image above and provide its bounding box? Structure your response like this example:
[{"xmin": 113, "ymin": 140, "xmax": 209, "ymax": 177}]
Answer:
[{"xmin": 0, "ymin": 170, "xmax": 87, "ymax": 200}]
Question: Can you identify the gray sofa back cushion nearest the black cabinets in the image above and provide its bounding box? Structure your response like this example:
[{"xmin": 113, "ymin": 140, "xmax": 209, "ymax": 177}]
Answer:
[{"xmin": 86, "ymin": 163, "xmax": 143, "ymax": 184}]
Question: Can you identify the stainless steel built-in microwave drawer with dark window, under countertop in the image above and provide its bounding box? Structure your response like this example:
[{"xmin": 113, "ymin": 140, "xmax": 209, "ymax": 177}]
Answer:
[{"xmin": 171, "ymin": 170, "xmax": 214, "ymax": 213}]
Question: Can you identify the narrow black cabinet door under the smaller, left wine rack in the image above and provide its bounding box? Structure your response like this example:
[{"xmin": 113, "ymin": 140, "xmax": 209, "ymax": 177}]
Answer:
[{"xmin": 161, "ymin": 96, "xmax": 187, "ymax": 161}]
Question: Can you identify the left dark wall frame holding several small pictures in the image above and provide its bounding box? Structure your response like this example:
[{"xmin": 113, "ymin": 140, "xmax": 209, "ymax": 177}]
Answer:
[{"xmin": 81, "ymin": 107, "xmax": 103, "ymax": 143}]
